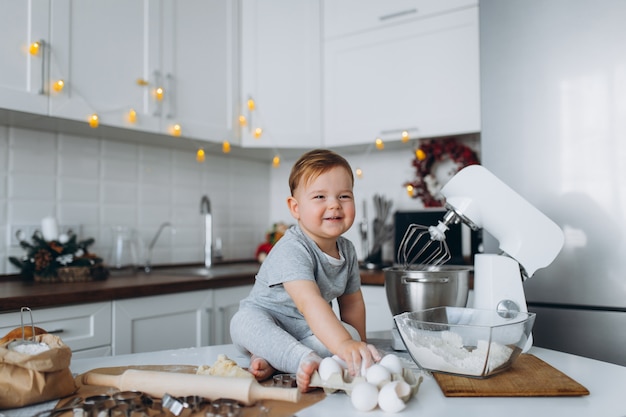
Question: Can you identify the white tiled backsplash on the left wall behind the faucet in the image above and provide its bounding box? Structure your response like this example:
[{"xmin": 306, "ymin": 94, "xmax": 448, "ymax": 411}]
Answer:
[{"xmin": 0, "ymin": 125, "xmax": 270, "ymax": 273}]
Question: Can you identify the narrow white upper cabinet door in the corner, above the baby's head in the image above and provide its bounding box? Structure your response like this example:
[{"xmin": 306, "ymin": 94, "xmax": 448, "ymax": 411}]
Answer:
[{"xmin": 239, "ymin": 0, "xmax": 321, "ymax": 148}]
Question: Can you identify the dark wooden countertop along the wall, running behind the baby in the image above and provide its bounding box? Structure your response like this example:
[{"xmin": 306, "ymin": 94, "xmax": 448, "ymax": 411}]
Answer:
[{"xmin": 0, "ymin": 263, "xmax": 384, "ymax": 312}]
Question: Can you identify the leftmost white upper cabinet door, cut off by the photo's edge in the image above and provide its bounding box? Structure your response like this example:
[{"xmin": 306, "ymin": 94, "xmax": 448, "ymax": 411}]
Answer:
[{"xmin": 0, "ymin": 0, "xmax": 50, "ymax": 115}]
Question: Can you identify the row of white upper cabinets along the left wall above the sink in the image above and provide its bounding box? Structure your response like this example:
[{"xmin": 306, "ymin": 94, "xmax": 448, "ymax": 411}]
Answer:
[{"xmin": 0, "ymin": 0, "xmax": 238, "ymax": 141}]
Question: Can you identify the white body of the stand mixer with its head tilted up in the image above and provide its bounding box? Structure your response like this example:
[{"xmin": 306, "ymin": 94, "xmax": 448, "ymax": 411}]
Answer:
[{"xmin": 388, "ymin": 165, "xmax": 564, "ymax": 351}]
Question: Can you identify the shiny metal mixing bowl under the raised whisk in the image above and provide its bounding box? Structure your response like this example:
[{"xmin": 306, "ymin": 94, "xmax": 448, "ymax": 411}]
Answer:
[{"xmin": 383, "ymin": 265, "xmax": 471, "ymax": 316}]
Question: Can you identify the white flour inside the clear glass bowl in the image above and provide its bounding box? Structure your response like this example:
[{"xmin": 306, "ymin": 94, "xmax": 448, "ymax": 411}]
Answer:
[{"xmin": 405, "ymin": 331, "xmax": 513, "ymax": 376}]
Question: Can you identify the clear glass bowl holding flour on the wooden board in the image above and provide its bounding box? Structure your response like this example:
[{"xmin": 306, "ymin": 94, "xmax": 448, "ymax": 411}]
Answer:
[{"xmin": 394, "ymin": 307, "xmax": 535, "ymax": 378}]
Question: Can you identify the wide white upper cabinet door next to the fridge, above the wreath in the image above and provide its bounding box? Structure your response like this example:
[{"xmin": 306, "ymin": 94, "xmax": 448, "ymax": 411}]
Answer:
[{"xmin": 323, "ymin": 2, "xmax": 480, "ymax": 147}]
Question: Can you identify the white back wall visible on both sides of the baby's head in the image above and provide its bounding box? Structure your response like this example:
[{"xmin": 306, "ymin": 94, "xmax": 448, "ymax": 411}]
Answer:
[{"xmin": 270, "ymin": 147, "xmax": 432, "ymax": 260}]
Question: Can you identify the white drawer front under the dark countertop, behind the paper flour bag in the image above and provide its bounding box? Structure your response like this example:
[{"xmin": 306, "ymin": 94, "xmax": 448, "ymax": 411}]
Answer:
[{"xmin": 0, "ymin": 302, "xmax": 112, "ymax": 358}]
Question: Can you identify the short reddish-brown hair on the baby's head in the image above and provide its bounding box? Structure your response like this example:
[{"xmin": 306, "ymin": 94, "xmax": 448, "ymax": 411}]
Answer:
[{"xmin": 289, "ymin": 149, "xmax": 354, "ymax": 196}]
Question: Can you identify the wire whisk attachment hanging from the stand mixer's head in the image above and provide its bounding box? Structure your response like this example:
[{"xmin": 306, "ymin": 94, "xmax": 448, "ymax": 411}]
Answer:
[{"xmin": 397, "ymin": 211, "xmax": 457, "ymax": 270}]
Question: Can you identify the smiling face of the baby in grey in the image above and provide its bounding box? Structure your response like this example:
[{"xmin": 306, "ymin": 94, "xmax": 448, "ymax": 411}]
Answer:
[{"xmin": 287, "ymin": 167, "xmax": 355, "ymax": 250}]
